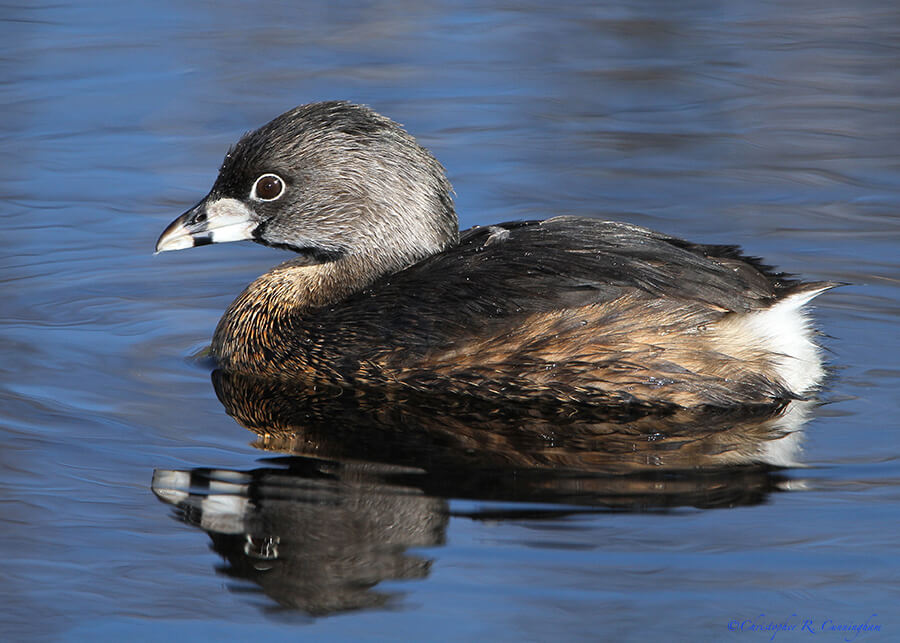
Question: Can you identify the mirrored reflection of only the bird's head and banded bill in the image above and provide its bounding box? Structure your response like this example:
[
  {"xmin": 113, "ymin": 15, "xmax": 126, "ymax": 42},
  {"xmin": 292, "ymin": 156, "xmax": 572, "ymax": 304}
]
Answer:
[{"xmin": 153, "ymin": 458, "xmax": 447, "ymax": 615}]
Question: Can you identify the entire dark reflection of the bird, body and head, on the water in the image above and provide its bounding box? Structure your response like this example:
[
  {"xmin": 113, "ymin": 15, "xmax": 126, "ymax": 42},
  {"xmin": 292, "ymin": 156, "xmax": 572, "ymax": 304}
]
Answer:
[{"xmin": 153, "ymin": 371, "xmax": 813, "ymax": 615}]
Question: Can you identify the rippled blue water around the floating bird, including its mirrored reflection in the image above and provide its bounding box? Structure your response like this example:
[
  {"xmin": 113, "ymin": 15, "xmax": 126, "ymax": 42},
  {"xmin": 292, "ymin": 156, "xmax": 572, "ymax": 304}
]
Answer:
[{"xmin": 0, "ymin": 1, "xmax": 900, "ymax": 641}]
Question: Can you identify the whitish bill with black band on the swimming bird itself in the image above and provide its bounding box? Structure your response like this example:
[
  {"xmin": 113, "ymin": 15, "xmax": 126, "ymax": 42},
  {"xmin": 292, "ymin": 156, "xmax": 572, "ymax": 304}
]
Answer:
[{"xmin": 156, "ymin": 197, "xmax": 257, "ymax": 252}]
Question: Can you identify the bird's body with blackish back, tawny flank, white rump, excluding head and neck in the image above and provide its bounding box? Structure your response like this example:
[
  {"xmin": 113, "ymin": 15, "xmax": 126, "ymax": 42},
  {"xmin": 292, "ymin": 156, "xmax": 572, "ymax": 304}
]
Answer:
[{"xmin": 270, "ymin": 217, "xmax": 830, "ymax": 406}]
